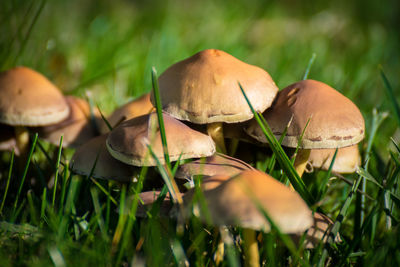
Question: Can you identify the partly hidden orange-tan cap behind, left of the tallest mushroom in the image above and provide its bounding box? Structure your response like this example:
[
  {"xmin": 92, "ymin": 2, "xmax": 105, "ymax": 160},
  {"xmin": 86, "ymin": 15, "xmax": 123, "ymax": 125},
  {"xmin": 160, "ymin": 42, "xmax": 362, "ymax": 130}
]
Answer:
[{"xmin": 100, "ymin": 93, "xmax": 154, "ymax": 133}]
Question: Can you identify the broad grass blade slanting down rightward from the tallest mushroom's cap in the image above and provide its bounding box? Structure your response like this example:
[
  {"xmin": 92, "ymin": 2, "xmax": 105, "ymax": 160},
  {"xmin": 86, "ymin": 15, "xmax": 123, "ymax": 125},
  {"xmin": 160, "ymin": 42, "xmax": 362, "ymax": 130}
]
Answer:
[{"xmin": 238, "ymin": 83, "xmax": 314, "ymax": 205}]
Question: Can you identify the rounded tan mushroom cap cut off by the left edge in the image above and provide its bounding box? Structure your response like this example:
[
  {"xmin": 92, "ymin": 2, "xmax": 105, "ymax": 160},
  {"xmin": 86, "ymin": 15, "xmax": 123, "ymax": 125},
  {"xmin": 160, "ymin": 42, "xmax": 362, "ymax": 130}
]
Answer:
[{"xmin": 0, "ymin": 67, "xmax": 69, "ymax": 126}]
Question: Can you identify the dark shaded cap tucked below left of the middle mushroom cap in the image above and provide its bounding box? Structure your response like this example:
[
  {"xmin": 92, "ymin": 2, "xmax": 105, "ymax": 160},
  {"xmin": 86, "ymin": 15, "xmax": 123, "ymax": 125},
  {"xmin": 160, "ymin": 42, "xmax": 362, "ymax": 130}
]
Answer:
[{"xmin": 70, "ymin": 135, "xmax": 140, "ymax": 182}]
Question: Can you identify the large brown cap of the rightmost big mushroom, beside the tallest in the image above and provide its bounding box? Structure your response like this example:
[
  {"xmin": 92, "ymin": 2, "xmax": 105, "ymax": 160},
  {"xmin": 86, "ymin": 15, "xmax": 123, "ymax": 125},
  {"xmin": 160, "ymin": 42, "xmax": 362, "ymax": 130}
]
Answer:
[{"xmin": 246, "ymin": 80, "xmax": 365, "ymax": 149}]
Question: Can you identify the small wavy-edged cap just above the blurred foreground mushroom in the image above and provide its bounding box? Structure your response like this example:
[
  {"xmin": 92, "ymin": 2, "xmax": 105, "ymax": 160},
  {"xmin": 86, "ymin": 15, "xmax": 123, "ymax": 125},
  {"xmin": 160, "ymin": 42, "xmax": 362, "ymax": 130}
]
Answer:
[{"xmin": 175, "ymin": 153, "xmax": 254, "ymax": 180}]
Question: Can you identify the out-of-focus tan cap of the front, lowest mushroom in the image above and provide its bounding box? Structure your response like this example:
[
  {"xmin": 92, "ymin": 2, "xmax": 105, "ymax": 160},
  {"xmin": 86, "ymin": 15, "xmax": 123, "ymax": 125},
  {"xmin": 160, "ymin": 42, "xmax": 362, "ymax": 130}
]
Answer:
[{"xmin": 184, "ymin": 170, "xmax": 313, "ymax": 233}]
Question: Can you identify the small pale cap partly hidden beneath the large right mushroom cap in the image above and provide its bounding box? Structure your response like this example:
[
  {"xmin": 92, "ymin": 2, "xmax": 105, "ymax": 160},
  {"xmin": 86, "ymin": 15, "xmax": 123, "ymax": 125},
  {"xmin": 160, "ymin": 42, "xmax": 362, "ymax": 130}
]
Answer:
[{"xmin": 308, "ymin": 145, "xmax": 361, "ymax": 173}]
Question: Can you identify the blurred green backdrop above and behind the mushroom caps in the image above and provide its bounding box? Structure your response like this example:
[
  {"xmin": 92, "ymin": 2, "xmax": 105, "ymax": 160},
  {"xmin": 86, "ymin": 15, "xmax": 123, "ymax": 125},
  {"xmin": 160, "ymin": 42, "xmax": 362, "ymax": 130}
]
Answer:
[{"xmin": 0, "ymin": 0, "xmax": 400, "ymax": 150}]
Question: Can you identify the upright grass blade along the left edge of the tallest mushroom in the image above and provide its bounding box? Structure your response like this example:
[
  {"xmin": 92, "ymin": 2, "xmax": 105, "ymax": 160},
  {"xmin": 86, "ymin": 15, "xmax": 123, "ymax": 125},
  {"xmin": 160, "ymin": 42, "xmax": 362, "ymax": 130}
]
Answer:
[{"xmin": 151, "ymin": 67, "xmax": 171, "ymax": 168}]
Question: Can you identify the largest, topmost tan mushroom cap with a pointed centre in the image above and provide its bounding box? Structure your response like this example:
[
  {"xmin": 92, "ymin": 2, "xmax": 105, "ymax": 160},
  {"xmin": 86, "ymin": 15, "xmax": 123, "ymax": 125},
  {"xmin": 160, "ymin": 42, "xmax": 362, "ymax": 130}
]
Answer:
[{"xmin": 152, "ymin": 49, "xmax": 278, "ymax": 124}]
